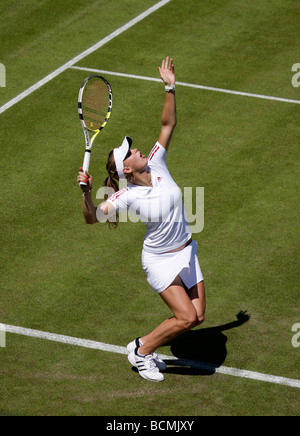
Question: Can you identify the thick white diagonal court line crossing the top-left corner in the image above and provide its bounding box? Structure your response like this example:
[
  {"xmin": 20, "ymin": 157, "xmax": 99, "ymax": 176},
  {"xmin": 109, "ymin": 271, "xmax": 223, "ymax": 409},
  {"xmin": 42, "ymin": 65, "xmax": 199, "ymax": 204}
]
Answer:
[{"xmin": 0, "ymin": 0, "xmax": 171, "ymax": 114}]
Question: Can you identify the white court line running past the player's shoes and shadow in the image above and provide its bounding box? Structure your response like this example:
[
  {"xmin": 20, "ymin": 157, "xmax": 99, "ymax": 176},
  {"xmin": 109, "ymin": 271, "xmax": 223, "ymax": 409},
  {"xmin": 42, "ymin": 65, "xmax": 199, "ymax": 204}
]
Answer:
[{"xmin": 0, "ymin": 324, "xmax": 300, "ymax": 388}]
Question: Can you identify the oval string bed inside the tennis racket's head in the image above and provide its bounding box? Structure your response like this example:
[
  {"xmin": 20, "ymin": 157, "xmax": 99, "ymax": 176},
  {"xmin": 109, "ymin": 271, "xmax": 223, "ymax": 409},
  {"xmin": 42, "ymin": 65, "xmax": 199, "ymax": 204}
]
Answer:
[{"xmin": 82, "ymin": 78, "xmax": 109, "ymax": 130}]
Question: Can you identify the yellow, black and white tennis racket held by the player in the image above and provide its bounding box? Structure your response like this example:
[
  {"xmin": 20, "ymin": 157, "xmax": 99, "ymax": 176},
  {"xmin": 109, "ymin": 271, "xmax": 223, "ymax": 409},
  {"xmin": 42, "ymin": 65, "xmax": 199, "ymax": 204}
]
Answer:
[{"xmin": 78, "ymin": 74, "xmax": 112, "ymax": 185}]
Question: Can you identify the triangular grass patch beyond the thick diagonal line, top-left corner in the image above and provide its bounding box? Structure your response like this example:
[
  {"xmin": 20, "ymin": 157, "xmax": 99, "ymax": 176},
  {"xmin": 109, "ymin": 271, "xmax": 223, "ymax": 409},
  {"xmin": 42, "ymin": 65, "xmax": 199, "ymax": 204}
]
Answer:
[{"xmin": 0, "ymin": 0, "xmax": 159, "ymax": 103}]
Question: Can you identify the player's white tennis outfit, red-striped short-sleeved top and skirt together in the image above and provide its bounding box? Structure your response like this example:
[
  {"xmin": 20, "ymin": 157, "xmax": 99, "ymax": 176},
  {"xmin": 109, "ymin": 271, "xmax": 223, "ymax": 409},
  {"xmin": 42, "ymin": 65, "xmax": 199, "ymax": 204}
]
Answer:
[{"xmin": 107, "ymin": 142, "xmax": 203, "ymax": 293}]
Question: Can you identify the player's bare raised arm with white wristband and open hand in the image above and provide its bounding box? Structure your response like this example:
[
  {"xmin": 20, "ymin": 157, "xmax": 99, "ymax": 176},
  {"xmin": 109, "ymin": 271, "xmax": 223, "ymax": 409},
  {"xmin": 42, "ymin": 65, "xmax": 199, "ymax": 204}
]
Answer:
[{"xmin": 158, "ymin": 56, "xmax": 177, "ymax": 149}]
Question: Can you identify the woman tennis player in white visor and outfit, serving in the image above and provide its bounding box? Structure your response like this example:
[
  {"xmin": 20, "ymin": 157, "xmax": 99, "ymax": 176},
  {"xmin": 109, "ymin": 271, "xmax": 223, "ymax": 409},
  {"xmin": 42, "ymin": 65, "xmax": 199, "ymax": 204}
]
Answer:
[{"xmin": 77, "ymin": 57, "xmax": 205, "ymax": 382}]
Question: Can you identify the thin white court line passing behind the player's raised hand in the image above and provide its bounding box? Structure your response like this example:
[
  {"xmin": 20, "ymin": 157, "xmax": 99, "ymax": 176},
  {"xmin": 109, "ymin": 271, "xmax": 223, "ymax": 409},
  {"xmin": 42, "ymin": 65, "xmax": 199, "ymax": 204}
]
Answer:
[{"xmin": 70, "ymin": 66, "xmax": 300, "ymax": 104}]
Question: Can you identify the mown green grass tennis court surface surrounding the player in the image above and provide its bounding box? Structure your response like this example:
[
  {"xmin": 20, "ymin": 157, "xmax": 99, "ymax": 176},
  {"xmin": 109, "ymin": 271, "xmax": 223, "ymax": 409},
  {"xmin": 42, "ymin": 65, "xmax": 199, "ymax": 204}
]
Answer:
[{"xmin": 0, "ymin": 0, "xmax": 300, "ymax": 416}]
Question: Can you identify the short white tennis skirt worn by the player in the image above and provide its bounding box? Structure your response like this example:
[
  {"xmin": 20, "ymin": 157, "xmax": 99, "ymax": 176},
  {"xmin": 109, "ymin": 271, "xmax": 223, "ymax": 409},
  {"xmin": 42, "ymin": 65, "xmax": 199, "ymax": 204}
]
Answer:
[{"xmin": 142, "ymin": 241, "xmax": 203, "ymax": 294}]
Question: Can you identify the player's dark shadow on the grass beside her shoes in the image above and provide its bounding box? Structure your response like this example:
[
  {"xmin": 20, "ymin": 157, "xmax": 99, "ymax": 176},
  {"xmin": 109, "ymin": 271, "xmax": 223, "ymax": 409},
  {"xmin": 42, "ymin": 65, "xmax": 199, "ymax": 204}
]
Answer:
[{"xmin": 164, "ymin": 311, "xmax": 250, "ymax": 375}]
